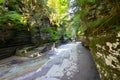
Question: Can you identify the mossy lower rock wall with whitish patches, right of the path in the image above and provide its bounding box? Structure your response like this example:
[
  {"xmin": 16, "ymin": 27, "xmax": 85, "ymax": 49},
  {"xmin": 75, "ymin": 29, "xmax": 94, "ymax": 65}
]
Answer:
[{"xmin": 90, "ymin": 33, "xmax": 120, "ymax": 80}]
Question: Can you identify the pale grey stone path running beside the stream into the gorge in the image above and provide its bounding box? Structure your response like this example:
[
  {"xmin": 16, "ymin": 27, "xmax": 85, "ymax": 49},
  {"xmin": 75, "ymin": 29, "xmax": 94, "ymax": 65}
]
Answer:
[{"xmin": 11, "ymin": 42, "xmax": 100, "ymax": 80}]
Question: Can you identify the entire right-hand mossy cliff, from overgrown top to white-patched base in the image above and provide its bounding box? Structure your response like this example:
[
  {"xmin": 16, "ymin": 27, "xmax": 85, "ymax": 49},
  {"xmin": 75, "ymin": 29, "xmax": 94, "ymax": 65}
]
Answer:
[{"xmin": 78, "ymin": 0, "xmax": 120, "ymax": 80}]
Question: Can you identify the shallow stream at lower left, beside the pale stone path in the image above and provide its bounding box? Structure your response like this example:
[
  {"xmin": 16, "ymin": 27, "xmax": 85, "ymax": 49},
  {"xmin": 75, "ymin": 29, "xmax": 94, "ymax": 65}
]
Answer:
[{"xmin": 0, "ymin": 54, "xmax": 50, "ymax": 80}]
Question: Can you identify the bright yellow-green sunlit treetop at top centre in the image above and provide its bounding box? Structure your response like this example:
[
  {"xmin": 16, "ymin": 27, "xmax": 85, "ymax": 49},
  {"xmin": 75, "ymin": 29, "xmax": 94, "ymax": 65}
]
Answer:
[{"xmin": 47, "ymin": 0, "xmax": 69, "ymax": 23}]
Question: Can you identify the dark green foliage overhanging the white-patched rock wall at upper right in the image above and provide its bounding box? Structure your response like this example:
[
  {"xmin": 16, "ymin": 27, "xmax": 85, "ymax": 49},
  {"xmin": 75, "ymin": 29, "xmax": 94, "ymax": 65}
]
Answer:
[{"xmin": 73, "ymin": 0, "xmax": 120, "ymax": 36}]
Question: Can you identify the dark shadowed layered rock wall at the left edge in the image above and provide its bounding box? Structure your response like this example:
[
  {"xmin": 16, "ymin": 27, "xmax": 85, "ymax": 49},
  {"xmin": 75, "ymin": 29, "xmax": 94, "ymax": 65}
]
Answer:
[{"xmin": 0, "ymin": 30, "xmax": 31, "ymax": 59}]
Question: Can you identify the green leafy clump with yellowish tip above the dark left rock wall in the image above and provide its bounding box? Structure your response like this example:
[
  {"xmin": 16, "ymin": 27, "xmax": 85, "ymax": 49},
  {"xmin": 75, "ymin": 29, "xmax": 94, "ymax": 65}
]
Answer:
[{"xmin": 0, "ymin": 11, "xmax": 26, "ymax": 30}]
